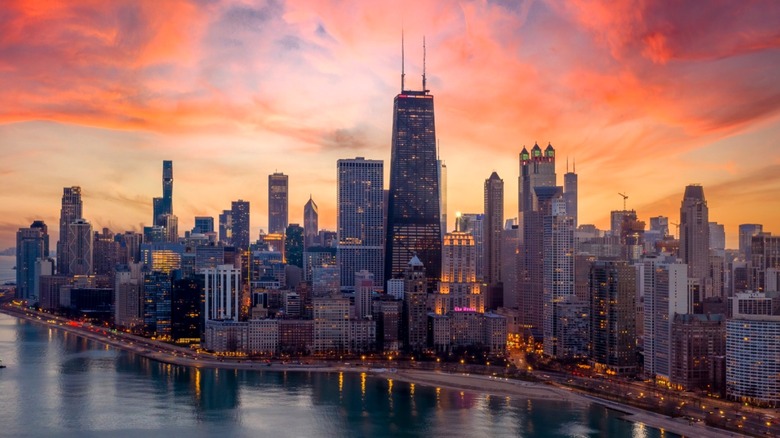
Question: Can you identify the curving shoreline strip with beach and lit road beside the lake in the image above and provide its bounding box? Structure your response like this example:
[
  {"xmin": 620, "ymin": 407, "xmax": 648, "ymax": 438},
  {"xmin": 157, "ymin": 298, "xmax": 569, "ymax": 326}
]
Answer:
[{"xmin": 0, "ymin": 306, "xmax": 741, "ymax": 438}]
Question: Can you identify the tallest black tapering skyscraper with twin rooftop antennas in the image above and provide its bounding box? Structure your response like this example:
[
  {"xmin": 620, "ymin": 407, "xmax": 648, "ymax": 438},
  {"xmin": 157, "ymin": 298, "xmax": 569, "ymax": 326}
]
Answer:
[{"xmin": 385, "ymin": 62, "xmax": 442, "ymax": 289}]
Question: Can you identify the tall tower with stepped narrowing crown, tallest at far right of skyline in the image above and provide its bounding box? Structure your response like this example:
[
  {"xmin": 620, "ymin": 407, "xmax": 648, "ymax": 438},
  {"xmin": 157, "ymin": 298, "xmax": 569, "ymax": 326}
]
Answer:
[{"xmin": 680, "ymin": 185, "xmax": 710, "ymax": 288}]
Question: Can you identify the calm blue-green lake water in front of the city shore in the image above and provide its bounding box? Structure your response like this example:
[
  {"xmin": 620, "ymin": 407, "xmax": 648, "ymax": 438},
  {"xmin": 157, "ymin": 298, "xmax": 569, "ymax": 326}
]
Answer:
[{"xmin": 0, "ymin": 314, "xmax": 668, "ymax": 437}]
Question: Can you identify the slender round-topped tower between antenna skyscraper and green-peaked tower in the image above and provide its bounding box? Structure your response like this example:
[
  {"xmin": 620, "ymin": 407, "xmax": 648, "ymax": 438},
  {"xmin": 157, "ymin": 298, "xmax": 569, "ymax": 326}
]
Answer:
[{"xmin": 483, "ymin": 172, "xmax": 504, "ymax": 285}]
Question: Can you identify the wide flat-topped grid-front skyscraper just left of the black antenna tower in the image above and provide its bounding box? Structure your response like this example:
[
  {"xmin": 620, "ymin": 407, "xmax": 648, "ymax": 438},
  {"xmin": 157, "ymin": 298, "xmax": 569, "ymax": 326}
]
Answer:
[{"xmin": 336, "ymin": 157, "xmax": 384, "ymax": 287}]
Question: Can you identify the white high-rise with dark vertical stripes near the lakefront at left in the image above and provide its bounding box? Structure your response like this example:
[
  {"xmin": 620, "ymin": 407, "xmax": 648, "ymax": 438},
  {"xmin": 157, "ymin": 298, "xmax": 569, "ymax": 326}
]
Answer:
[{"xmin": 201, "ymin": 265, "xmax": 241, "ymax": 322}]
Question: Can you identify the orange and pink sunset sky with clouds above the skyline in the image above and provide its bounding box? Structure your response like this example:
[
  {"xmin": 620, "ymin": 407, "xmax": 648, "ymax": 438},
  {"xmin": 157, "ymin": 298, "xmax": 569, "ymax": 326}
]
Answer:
[{"xmin": 0, "ymin": 0, "xmax": 780, "ymax": 248}]
